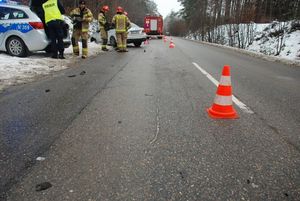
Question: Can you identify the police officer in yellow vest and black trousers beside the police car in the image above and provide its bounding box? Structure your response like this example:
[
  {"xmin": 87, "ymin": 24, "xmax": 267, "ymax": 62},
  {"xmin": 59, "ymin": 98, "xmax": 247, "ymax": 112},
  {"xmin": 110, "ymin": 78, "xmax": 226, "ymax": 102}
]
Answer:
[{"xmin": 43, "ymin": 0, "xmax": 65, "ymax": 59}]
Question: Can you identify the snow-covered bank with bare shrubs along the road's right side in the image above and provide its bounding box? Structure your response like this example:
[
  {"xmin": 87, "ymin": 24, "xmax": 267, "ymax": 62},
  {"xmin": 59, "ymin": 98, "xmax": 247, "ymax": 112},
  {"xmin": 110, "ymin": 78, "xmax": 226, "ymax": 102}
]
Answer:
[{"xmin": 186, "ymin": 20, "xmax": 300, "ymax": 65}]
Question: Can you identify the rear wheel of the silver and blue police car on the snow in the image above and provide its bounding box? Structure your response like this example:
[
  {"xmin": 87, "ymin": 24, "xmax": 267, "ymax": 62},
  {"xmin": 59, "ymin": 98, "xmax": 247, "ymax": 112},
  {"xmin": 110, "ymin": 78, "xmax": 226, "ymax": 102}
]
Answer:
[{"xmin": 6, "ymin": 37, "xmax": 27, "ymax": 57}]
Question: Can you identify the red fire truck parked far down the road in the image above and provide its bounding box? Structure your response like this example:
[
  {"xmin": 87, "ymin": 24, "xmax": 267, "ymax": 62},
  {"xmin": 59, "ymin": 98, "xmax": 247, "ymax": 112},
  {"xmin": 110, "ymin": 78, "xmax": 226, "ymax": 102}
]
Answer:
[{"xmin": 144, "ymin": 15, "xmax": 163, "ymax": 39}]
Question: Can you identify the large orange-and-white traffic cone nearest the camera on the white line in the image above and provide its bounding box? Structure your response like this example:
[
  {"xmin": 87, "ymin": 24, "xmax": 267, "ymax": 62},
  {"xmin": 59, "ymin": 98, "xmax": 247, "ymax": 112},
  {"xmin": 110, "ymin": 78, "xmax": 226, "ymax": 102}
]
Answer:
[{"xmin": 207, "ymin": 66, "xmax": 238, "ymax": 119}]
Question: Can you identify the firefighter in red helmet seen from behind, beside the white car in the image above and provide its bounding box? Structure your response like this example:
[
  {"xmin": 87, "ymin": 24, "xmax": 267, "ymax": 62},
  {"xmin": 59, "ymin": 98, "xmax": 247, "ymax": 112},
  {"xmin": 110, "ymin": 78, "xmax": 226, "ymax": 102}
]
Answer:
[{"xmin": 112, "ymin": 6, "xmax": 130, "ymax": 52}]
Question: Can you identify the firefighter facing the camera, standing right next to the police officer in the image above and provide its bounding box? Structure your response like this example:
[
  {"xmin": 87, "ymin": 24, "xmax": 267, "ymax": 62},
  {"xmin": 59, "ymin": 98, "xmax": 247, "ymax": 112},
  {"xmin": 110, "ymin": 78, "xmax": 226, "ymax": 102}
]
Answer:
[{"xmin": 70, "ymin": 0, "xmax": 93, "ymax": 59}]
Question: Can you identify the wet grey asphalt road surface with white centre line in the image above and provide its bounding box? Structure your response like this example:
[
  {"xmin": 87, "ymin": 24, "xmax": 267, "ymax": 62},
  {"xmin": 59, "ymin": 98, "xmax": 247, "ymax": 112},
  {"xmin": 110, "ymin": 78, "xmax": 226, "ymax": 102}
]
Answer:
[{"xmin": 0, "ymin": 38, "xmax": 300, "ymax": 201}]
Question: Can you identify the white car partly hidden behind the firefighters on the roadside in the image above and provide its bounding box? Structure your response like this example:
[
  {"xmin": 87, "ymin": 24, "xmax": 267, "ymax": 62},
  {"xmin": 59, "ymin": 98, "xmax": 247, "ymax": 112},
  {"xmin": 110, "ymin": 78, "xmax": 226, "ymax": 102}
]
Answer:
[{"xmin": 91, "ymin": 23, "xmax": 147, "ymax": 47}]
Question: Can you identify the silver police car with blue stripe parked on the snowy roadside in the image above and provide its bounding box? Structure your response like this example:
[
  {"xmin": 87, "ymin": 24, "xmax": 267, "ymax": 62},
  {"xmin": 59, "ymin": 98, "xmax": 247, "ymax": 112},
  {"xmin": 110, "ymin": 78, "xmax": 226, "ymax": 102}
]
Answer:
[{"xmin": 0, "ymin": 0, "xmax": 71, "ymax": 57}]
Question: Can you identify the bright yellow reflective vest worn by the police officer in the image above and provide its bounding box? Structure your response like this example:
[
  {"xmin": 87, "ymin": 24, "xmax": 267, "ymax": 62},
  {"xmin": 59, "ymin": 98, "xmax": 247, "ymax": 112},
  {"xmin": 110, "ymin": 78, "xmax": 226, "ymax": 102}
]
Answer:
[{"xmin": 43, "ymin": 0, "xmax": 63, "ymax": 24}]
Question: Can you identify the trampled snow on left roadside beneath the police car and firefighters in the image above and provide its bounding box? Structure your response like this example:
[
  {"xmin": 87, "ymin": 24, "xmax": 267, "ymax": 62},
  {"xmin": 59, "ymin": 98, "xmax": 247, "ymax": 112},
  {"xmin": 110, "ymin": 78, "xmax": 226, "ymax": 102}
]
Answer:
[{"xmin": 0, "ymin": 42, "xmax": 102, "ymax": 92}]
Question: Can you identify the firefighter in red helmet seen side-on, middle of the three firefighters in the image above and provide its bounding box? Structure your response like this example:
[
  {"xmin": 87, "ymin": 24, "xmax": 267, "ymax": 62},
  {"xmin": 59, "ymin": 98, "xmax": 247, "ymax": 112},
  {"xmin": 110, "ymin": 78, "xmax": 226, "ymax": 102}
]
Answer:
[{"xmin": 98, "ymin": 6, "xmax": 110, "ymax": 51}]
